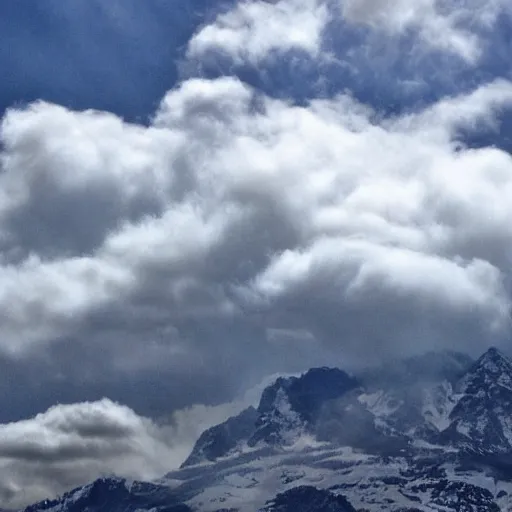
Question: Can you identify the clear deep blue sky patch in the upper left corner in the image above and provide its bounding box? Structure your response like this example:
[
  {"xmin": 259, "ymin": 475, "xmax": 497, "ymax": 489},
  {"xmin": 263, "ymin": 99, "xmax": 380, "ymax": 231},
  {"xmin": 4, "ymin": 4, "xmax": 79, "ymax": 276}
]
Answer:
[{"xmin": 0, "ymin": 0, "xmax": 225, "ymax": 120}]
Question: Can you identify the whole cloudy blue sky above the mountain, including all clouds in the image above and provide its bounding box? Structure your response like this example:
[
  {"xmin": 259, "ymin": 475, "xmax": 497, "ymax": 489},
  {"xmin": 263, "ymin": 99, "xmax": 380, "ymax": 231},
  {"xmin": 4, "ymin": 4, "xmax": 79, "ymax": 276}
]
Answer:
[{"xmin": 0, "ymin": 0, "xmax": 512, "ymax": 508}]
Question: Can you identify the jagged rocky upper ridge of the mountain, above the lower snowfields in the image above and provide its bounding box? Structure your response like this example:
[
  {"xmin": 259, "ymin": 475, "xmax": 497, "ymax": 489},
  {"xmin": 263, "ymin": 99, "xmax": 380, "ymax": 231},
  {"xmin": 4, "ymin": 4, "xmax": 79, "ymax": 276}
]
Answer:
[{"xmin": 184, "ymin": 349, "xmax": 512, "ymax": 466}]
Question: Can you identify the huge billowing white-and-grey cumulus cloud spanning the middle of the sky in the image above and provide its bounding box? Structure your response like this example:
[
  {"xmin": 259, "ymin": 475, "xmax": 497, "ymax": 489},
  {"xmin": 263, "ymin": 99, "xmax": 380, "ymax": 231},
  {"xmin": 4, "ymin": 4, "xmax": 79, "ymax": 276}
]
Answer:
[{"xmin": 0, "ymin": 78, "xmax": 512, "ymax": 366}]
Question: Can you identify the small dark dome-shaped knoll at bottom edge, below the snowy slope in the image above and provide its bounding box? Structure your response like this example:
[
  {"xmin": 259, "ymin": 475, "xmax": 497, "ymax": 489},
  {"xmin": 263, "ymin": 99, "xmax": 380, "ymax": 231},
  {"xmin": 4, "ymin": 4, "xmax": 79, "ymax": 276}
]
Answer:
[{"xmin": 261, "ymin": 486, "xmax": 356, "ymax": 512}]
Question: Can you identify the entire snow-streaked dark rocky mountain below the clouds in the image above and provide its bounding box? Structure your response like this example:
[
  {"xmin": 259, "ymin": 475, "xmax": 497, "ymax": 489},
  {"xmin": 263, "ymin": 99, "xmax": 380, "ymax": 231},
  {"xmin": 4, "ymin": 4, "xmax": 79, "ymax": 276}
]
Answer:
[{"xmin": 19, "ymin": 348, "xmax": 512, "ymax": 512}]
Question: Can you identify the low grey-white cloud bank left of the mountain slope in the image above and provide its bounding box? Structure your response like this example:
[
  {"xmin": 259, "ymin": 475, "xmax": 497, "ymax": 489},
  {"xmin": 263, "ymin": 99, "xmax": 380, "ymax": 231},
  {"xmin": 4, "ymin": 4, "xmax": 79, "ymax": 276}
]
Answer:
[{"xmin": 0, "ymin": 399, "xmax": 244, "ymax": 508}]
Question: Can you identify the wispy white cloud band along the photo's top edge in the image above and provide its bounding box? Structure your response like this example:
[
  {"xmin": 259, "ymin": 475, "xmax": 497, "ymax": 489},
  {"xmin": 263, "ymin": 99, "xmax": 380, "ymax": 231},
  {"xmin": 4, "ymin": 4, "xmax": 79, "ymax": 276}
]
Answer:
[{"xmin": 188, "ymin": 0, "xmax": 506, "ymax": 65}]
